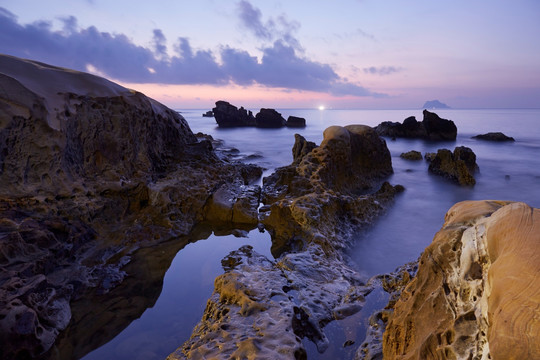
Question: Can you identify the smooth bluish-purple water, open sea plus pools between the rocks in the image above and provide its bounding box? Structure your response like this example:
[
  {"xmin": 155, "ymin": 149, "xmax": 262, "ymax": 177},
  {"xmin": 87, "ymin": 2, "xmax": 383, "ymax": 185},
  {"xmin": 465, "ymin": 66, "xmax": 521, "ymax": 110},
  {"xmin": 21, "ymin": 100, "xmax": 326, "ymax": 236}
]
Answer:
[{"xmin": 83, "ymin": 109, "xmax": 540, "ymax": 360}]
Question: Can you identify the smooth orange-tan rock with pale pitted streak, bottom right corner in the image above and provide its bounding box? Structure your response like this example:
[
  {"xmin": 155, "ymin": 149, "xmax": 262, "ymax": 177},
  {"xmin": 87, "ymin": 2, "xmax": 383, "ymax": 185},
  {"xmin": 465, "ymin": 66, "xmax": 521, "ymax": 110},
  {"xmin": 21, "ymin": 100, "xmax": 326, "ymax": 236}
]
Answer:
[{"xmin": 383, "ymin": 201, "xmax": 540, "ymax": 359}]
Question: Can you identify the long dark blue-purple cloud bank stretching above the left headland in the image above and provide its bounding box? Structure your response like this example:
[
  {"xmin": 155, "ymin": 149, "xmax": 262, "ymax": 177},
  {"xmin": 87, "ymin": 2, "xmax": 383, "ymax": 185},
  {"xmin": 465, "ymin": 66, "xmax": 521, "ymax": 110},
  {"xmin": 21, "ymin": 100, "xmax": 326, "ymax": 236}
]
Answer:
[{"xmin": 0, "ymin": 5, "xmax": 381, "ymax": 96}]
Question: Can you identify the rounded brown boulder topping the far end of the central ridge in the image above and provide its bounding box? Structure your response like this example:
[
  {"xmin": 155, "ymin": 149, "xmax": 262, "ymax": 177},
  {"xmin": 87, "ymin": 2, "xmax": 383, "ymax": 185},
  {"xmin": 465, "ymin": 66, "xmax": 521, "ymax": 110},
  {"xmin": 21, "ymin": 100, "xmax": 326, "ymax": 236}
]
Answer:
[{"xmin": 263, "ymin": 125, "xmax": 393, "ymax": 204}]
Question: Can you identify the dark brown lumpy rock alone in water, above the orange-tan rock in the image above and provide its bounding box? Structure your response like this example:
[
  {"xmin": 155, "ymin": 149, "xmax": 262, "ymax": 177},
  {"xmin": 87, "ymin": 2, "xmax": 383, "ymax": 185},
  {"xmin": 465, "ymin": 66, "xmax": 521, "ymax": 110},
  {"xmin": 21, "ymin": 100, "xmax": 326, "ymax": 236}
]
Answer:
[{"xmin": 428, "ymin": 146, "xmax": 478, "ymax": 185}]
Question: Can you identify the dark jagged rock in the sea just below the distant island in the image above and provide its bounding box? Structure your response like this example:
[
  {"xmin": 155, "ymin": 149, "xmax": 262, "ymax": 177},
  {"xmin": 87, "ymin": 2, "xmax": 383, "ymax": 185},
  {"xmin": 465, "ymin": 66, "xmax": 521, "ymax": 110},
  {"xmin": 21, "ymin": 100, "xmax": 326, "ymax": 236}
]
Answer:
[{"xmin": 375, "ymin": 110, "xmax": 457, "ymax": 140}]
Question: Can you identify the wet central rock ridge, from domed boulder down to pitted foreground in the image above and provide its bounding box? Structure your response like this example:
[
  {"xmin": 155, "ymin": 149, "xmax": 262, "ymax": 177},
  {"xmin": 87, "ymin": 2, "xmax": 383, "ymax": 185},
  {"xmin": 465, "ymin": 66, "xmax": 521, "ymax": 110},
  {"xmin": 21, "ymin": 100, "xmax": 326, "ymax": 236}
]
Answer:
[{"xmin": 173, "ymin": 125, "xmax": 401, "ymax": 360}]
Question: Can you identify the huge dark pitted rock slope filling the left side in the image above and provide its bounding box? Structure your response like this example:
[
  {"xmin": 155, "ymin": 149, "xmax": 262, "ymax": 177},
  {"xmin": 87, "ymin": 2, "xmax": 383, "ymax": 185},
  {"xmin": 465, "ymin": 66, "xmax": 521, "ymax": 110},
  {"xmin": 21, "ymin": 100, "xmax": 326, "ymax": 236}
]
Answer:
[{"xmin": 0, "ymin": 56, "xmax": 261, "ymax": 359}]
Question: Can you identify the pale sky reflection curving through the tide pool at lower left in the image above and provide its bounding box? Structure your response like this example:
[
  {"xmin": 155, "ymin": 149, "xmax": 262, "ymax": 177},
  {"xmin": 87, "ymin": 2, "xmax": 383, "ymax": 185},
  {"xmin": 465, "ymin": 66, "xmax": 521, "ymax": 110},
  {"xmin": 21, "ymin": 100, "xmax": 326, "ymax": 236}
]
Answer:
[{"xmin": 83, "ymin": 230, "xmax": 272, "ymax": 360}]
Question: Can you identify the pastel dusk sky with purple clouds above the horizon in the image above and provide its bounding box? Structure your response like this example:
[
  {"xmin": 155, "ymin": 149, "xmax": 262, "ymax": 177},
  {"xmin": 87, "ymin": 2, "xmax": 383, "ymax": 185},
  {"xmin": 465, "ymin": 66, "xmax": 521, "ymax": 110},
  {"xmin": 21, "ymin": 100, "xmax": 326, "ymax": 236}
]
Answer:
[{"xmin": 0, "ymin": 0, "xmax": 540, "ymax": 109}]
